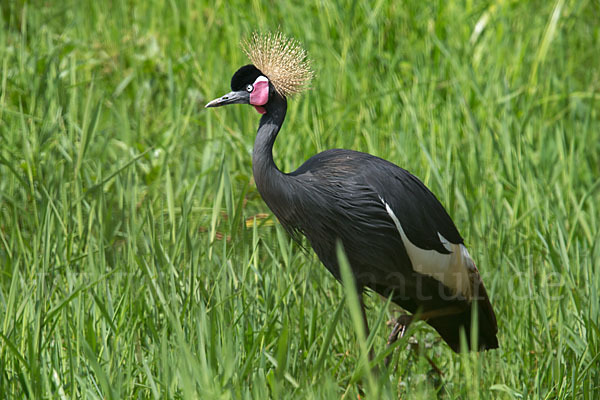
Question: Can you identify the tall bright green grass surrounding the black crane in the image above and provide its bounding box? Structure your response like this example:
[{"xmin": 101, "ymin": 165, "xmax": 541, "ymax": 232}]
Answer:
[{"xmin": 0, "ymin": 0, "xmax": 600, "ymax": 399}]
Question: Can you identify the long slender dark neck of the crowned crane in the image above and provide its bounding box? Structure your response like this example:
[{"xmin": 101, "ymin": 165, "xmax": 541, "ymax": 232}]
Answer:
[{"xmin": 252, "ymin": 92, "xmax": 287, "ymax": 205}]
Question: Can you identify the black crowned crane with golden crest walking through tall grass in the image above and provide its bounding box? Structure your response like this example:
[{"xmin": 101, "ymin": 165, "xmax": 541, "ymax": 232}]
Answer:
[{"xmin": 206, "ymin": 34, "xmax": 498, "ymax": 352}]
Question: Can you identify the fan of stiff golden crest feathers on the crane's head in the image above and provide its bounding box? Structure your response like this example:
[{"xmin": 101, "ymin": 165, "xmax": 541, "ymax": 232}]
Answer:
[{"xmin": 242, "ymin": 32, "xmax": 314, "ymax": 97}]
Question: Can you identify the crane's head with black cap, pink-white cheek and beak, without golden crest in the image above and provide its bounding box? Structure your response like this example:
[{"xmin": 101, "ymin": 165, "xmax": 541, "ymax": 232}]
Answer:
[{"xmin": 205, "ymin": 64, "xmax": 275, "ymax": 114}]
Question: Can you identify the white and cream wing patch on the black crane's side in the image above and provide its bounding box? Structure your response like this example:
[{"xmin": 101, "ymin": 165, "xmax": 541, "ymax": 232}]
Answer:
[{"xmin": 380, "ymin": 197, "xmax": 477, "ymax": 299}]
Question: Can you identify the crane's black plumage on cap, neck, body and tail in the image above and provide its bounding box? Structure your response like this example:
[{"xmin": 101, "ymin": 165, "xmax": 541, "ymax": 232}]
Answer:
[{"xmin": 209, "ymin": 62, "xmax": 498, "ymax": 351}]
